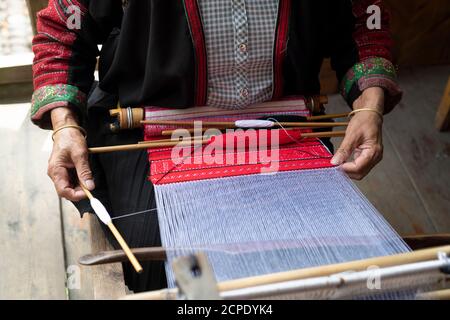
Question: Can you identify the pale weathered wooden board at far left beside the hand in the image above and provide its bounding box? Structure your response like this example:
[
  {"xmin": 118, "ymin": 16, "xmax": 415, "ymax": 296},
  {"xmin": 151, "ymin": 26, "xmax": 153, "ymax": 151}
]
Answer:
[{"xmin": 0, "ymin": 105, "xmax": 66, "ymax": 300}]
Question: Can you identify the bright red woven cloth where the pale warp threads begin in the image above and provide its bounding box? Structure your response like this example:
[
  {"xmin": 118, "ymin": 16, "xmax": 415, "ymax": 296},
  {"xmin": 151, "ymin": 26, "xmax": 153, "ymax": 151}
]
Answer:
[{"xmin": 145, "ymin": 100, "xmax": 332, "ymax": 185}]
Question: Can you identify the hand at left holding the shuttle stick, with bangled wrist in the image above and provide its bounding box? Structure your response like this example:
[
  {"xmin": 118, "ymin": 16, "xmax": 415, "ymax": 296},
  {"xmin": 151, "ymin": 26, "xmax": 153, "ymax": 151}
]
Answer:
[{"xmin": 47, "ymin": 108, "xmax": 95, "ymax": 201}]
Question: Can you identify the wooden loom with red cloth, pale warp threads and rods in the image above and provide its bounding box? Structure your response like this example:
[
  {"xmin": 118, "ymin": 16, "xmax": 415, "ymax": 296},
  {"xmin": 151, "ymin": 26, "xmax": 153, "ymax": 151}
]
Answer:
[{"xmin": 80, "ymin": 98, "xmax": 450, "ymax": 299}]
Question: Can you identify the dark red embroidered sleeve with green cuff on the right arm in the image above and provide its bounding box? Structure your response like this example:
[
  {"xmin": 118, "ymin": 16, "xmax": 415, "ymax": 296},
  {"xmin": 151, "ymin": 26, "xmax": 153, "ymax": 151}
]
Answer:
[{"xmin": 341, "ymin": 0, "xmax": 402, "ymax": 112}]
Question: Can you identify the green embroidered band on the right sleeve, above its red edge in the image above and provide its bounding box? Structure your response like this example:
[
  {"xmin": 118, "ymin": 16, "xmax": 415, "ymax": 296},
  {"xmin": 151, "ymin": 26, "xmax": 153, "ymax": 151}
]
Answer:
[{"xmin": 341, "ymin": 57, "xmax": 397, "ymax": 98}]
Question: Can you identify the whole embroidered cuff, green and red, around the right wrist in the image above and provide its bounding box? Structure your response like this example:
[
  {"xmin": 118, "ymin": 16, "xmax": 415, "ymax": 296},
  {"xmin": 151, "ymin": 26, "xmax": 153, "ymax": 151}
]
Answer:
[{"xmin": 341, "ymin": 57, "xmax": 403, "ymax": 113}]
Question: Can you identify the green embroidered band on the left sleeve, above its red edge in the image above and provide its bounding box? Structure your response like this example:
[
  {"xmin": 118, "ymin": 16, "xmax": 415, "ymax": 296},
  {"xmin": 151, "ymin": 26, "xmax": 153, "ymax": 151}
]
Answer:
[{"xmin": 31, "ymin": 84, "xmax": 86, "ymax": 117}]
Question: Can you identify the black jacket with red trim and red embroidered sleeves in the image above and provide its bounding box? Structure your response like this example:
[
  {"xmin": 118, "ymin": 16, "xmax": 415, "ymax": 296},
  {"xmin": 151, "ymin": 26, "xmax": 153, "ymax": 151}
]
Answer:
[{"xmin": 32, "ymin": 0, "xmax": 400, "ymax": 127}]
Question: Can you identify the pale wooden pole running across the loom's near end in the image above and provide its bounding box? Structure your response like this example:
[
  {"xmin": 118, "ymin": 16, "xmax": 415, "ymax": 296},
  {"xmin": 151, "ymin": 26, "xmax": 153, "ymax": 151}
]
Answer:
[{"xmin": 121, "ymin": 246, "xmax": 450, "ymax": 300}]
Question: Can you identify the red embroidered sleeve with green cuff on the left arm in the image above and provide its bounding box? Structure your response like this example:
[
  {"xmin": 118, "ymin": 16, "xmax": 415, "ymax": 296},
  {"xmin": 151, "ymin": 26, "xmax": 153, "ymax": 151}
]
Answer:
[{"xmin": 31, "ymin": 0, "xmax": 98, "ymax": 128}]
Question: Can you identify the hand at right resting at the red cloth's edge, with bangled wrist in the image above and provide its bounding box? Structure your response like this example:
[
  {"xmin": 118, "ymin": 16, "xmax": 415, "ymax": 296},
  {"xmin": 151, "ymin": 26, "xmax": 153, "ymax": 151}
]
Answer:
[{"xmin": 331, "ymin": 87, "xmax": 384, "ymax": 180}]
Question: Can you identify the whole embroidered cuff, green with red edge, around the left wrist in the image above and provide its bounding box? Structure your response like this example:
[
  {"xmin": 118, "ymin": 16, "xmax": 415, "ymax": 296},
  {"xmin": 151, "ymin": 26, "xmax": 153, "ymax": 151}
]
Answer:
[{"xmin": 31, "ymin": 84, "xmax": 87, "ymax": 129}]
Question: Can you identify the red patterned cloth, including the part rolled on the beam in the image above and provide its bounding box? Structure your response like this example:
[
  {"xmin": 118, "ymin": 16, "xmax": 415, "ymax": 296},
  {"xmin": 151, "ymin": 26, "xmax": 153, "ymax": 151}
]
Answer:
[{"xmin": 144, "ymin": 98, "xmax": 332, "ymax": 185}]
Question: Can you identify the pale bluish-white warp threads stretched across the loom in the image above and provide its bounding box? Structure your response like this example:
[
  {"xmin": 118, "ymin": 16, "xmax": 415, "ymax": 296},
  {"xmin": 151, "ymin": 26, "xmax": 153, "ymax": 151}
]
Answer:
[{"xmin": 155, "ymin": 168, "xmax": 410, "ymax": 298}]
